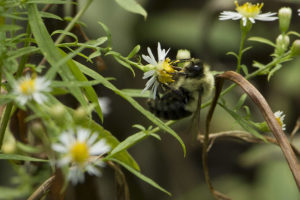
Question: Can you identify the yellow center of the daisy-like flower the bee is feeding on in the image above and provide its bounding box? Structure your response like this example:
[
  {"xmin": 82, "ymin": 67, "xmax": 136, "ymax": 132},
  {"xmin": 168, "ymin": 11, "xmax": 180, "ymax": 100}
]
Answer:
[{"xmin": 158, "ymin": 58, "xmax": 175, "ymax": 83}]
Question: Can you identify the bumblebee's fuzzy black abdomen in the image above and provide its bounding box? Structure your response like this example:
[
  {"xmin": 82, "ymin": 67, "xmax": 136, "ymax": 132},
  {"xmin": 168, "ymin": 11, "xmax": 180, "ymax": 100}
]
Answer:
[{"xmin": 148, "ymin": 90, "xmax": 192, "ymax": 120}]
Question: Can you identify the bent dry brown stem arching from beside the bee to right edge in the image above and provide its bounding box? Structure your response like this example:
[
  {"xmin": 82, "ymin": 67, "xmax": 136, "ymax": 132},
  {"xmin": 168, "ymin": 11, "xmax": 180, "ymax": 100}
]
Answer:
[{"xmin": 207, "ymin": 71, "xmax": 300, "ymax": 191}]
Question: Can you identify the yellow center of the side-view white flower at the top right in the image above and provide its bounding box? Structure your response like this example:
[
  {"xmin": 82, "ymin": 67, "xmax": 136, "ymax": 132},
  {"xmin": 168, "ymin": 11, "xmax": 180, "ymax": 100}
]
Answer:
[{"xmin": 234, "ymin": 1, "xmax": 264, "ymax": 18}]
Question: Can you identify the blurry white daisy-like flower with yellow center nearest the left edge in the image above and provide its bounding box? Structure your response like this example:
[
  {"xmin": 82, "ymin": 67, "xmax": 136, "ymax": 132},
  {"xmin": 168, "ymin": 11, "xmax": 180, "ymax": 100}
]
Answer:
[{"xmin": 13, "ymin": 75, "xmax": 51, "ymax": 105}]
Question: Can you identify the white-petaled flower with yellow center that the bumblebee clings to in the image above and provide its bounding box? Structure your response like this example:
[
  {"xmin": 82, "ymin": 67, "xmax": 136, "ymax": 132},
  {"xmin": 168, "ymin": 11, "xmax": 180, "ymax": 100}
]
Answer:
[{"xmin": 142, "ymin": 42, "xmax": 174, "ymax": 98}]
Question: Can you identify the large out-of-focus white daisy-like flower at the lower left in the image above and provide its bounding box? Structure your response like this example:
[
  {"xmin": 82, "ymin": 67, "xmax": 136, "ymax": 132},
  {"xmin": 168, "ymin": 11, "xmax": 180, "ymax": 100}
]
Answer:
[{"xmin": 52, "ymin": 127, "xmax": 111, "ymax": 185}]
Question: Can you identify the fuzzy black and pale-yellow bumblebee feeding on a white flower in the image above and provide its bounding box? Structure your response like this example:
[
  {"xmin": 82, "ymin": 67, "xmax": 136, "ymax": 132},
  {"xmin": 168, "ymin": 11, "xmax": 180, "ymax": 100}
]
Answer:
[{"xmin": 147, "ymin": 59, "xmax": 214, "ymax": 120}]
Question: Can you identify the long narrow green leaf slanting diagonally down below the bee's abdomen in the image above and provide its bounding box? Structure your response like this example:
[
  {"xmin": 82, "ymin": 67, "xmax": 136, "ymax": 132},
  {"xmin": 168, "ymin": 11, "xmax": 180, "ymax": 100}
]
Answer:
[{"xmin": 76, "ymin": 62, "xmax": 186, "ymax": 156}]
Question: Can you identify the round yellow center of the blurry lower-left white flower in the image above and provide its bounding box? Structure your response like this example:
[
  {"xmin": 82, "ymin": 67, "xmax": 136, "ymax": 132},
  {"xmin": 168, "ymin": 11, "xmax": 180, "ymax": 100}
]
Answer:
[{"xmin": 71, "ymin": 141, "xmax": 89, "ymax": 164}]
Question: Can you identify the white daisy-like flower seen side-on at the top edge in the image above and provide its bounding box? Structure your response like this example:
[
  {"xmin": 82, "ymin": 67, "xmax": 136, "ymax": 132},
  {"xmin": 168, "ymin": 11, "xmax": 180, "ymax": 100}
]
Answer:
[{"xmin": 219, "ymin": 1, "xmax": 278, "ymax": 26}]
